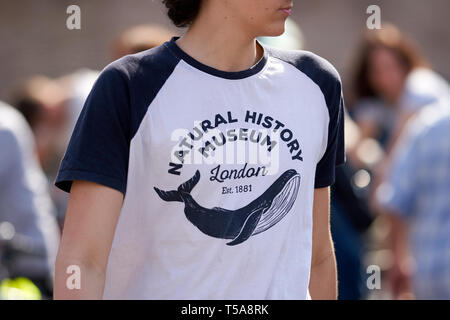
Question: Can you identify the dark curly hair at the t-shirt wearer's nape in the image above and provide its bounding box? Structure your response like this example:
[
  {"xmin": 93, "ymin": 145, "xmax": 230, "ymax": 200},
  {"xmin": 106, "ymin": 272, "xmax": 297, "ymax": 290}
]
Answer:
[{"xmin": 162, "ymin": 0, "xmax": 202, "ymax": 27}]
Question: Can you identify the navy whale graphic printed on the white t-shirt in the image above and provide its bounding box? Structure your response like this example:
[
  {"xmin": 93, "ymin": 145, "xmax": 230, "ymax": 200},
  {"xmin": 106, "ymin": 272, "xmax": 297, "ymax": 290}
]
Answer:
[{"xmin": 154, "ymin": 169, "xmax": 300, "ymax": 246}]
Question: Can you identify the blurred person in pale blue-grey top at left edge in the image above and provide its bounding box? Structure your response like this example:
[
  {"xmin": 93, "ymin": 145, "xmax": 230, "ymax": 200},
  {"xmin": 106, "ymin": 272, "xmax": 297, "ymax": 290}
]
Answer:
[{"xmin": 0, "ymin": 102, "xmax": 60, "ymax": 297}]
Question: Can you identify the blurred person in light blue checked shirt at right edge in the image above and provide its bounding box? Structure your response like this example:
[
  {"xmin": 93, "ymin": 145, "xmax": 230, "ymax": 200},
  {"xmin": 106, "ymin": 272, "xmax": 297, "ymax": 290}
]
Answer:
[{"xmin": 376, "ymin": 103, "xmax": 450, "ymax": 299}]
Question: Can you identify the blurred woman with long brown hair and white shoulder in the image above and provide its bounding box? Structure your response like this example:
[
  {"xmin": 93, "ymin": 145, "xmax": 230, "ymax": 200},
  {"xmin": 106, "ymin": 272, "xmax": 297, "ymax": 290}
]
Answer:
[{"xmin": 349, "ymin": 24, "xmax": 450, "ymax": 220}]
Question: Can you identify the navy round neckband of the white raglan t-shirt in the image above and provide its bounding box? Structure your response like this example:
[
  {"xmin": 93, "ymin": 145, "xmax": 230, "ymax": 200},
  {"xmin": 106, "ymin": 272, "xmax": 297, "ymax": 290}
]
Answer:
[{"xmin": 166, "ymin": 36, "xmax": 268, "ymax": 80}]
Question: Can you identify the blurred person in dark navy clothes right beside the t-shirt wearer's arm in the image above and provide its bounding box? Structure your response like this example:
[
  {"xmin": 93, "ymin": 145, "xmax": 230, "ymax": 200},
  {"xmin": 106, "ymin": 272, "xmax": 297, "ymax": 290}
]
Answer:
[{"xmin": 330, "ymin": 113, "xmax": 380, "ymax": 300}]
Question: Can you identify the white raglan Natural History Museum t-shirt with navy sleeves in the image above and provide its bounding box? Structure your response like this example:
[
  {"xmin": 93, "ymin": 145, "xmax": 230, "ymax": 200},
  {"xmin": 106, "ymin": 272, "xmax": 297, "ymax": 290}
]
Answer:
[{"xmin": 55, "ymin": 37, "xmax": 345, "ymax": 299}]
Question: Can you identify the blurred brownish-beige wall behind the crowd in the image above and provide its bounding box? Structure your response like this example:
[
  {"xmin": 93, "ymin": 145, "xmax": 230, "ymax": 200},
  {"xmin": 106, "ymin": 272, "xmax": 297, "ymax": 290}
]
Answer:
[{"xmin": 0, "ymin": 0, "xmax": 450, "ymax": 100}]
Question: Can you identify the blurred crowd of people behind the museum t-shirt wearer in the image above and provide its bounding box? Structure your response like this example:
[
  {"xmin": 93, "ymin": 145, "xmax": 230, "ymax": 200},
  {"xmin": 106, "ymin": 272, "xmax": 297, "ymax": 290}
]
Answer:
[{"xmin": 0, "ymin": 20, "xmax": 450, "ymax": 299}]
